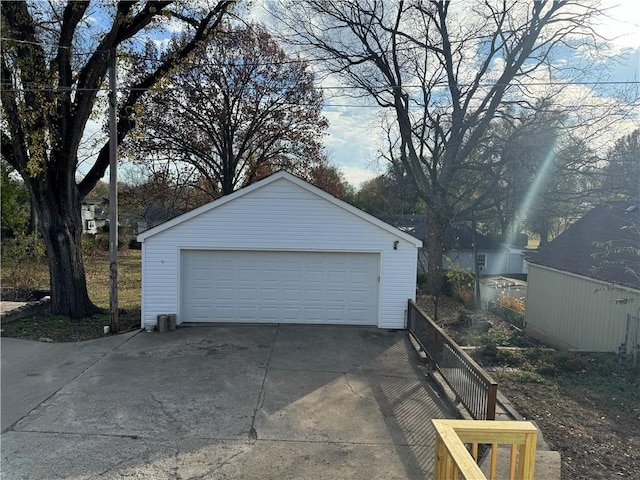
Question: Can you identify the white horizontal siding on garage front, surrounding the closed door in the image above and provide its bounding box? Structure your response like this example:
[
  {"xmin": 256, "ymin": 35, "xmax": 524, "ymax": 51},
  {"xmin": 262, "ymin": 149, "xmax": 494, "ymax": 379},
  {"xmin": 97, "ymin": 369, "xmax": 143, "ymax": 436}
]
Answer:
[{"xmin": 142, "ymin": 179, "xmax": 417, "ymax": 328}]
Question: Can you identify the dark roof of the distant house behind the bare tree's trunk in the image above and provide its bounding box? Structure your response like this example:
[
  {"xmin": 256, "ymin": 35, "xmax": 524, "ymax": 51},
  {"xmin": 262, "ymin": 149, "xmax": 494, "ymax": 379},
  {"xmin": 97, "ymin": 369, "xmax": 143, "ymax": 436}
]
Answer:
[{"xmin": 396, "ymin": 214, "xmax": 505, "ymax": 251}]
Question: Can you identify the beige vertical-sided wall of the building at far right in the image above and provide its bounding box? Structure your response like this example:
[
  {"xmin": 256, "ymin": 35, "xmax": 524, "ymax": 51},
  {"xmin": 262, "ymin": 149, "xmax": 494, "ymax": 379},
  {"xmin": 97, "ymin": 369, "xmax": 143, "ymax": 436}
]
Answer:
[{"xmin": 526, "ymin": 264, "xmax": 640, "ymax": 352}]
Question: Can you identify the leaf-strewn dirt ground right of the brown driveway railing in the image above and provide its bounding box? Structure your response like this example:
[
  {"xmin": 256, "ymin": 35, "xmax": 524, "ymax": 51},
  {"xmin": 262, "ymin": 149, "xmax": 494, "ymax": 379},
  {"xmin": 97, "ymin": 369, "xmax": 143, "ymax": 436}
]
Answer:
[{"xmin": 418, "ymin": 297, "xmax": 640, "ymax": 480}]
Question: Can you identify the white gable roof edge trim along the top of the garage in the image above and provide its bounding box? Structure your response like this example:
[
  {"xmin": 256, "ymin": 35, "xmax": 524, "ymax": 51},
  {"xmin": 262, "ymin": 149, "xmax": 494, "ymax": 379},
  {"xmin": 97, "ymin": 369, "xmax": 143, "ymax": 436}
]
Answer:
[{"xmin": 137, "ymin": 170, "xmax": 422, "ymax": 247}]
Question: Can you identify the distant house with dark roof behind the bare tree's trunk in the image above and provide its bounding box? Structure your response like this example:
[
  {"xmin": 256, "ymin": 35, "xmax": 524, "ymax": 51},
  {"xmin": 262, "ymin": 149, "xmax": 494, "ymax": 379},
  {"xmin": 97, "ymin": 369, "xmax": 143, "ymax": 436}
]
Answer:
[{"xmin": 396, "ymin": 215, "xmax": 527, "ymax": 275}]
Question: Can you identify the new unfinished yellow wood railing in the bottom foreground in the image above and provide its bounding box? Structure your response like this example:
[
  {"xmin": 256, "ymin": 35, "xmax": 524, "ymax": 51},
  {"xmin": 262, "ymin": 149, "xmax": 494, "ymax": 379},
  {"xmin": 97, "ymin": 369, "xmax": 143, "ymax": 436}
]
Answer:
[{"xmin": 432, "ymin": 420, "xmax": 538, "ymax": 480}]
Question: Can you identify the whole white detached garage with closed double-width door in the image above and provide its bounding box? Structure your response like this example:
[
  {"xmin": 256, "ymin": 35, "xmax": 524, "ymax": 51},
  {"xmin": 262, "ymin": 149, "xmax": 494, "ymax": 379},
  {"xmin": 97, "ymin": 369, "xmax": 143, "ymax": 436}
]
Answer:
[{"xmin": 138, "ymin": 172, "xmax": 422, "ymax": 328}]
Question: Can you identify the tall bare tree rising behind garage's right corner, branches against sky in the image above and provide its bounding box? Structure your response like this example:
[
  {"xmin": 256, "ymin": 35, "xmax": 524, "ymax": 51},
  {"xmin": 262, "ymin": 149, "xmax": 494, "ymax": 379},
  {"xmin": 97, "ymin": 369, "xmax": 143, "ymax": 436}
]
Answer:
[{"xmin": 274, "ymin": 0, "xmax": 599, "ymax": 292}]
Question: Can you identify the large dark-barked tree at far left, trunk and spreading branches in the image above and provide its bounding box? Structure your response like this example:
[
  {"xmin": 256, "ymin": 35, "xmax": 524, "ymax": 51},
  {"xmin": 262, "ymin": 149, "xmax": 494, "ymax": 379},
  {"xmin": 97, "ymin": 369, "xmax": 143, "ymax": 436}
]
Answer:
[{"xmin": 0, "ymin": 0, "xmax": 235, "ymax": 318}]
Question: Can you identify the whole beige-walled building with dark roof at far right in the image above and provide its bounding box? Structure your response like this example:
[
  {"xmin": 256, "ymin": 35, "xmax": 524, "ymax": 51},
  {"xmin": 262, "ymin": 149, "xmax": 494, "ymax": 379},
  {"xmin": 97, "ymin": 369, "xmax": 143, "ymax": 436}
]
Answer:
[{"xmin": 525, "ymin": 201, "xmax": 640, "ymax": 352}]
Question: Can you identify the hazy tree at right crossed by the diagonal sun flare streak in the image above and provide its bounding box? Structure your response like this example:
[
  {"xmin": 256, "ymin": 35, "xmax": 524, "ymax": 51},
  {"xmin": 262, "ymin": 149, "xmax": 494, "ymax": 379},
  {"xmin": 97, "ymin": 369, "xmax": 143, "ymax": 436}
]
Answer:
[{"xmin": 478, "ymin": 102, "xmax": 600, "ymax": 245}]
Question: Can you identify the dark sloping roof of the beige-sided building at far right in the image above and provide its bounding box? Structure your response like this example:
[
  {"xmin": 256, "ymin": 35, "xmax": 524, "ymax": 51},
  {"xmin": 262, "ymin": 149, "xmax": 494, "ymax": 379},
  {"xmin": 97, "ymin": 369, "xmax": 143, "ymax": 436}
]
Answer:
[{"xmin": 527, "ymin": 201, "xmax": 640, "ymax": 289}]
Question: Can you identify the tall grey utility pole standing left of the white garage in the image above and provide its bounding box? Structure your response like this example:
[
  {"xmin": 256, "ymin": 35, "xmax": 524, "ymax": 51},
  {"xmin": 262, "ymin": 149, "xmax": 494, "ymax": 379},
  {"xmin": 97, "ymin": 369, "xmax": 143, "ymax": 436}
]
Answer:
[{"xmin": 109, "ymin": 48, "xmax": 120, "ymax": 333}]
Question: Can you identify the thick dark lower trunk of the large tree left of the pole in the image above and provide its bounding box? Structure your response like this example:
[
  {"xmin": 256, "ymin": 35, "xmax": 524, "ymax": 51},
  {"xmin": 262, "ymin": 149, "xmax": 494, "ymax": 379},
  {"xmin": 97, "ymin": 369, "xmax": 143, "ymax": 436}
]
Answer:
[{"xmin": 32, "ymin": 180, "xmax": 99, "ymax": 318}]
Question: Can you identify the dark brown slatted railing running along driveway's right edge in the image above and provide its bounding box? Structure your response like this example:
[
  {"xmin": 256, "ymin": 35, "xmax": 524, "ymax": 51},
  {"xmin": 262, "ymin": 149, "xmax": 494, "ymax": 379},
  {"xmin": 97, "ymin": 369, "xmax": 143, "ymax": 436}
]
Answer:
[{"xmin": 407, "ymin": 300, "xmax": 498, "ymax": 420}]
